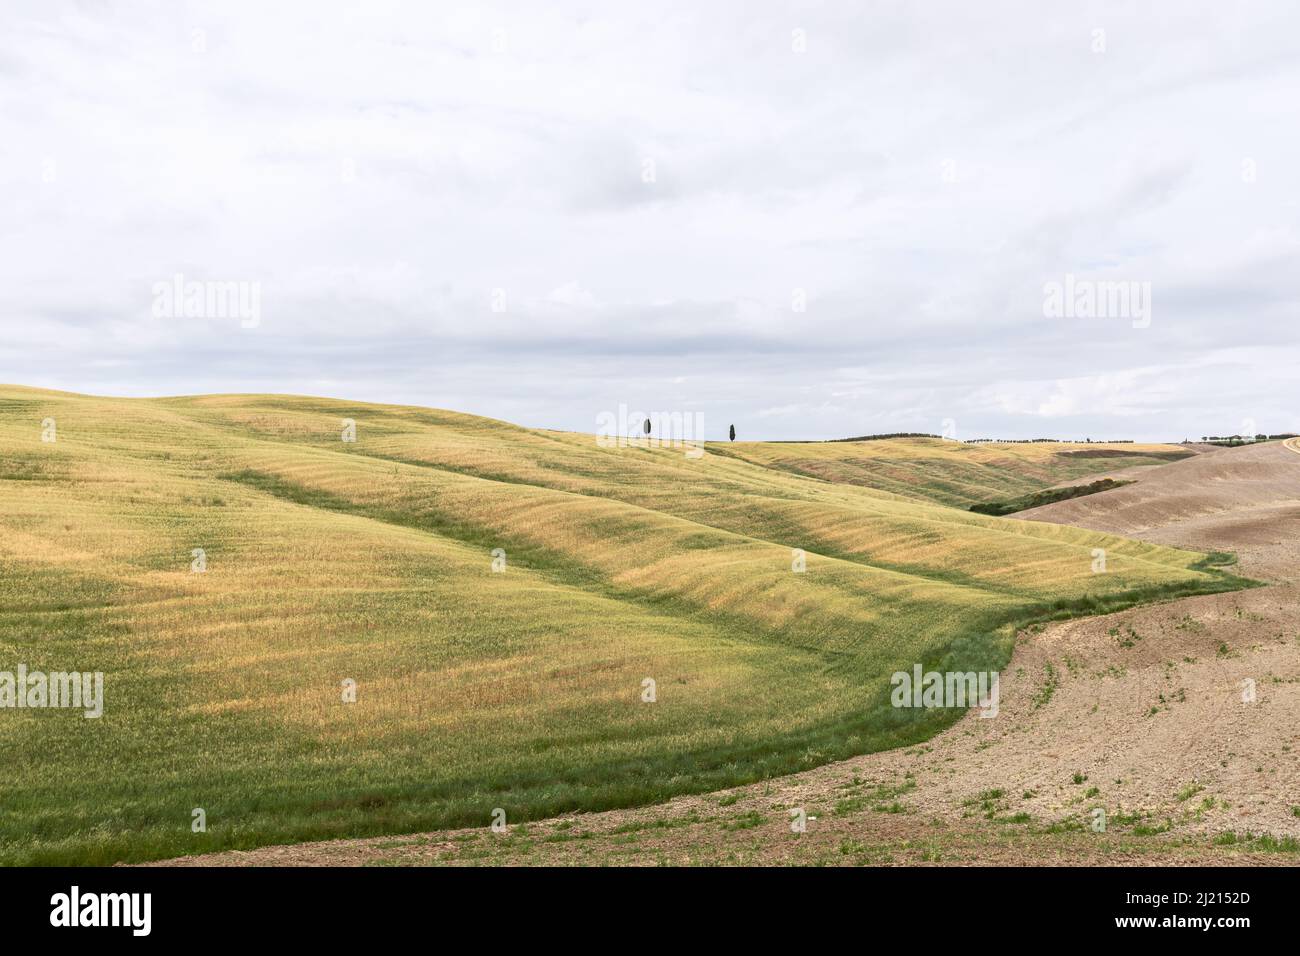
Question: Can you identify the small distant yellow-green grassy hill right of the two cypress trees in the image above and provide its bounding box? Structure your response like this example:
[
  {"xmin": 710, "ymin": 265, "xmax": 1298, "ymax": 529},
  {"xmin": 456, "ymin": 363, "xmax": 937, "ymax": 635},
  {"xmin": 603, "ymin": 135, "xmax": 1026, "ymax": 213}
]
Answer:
[{"xmin": 716, "ymin": 438, "xmax": 1193, "ymax": 507}]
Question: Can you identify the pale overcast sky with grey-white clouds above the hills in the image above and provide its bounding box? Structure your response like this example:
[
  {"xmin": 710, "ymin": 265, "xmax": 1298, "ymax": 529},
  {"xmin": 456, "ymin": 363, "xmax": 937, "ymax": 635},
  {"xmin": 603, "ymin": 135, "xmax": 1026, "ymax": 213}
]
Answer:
[{"xmin": 0, "ymin": 0, "xmax": 1300, "ymax": 441}]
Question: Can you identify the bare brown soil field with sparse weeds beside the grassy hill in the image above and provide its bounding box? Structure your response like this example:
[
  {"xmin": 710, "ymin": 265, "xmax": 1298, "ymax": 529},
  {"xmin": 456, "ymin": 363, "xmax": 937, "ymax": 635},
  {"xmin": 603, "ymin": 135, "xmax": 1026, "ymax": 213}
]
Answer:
[{"xmin": 154, "ymin": 442, "xmax": 1300, "ymax": 865}]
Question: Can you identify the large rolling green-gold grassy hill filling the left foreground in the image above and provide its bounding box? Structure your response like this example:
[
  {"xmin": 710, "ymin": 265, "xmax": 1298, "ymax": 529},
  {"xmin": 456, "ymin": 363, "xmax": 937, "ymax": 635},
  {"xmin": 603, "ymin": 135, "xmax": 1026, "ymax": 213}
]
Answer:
[{"xmin": 0, "ymin": 386, "xmax": 1239, "ymax": 864}]
